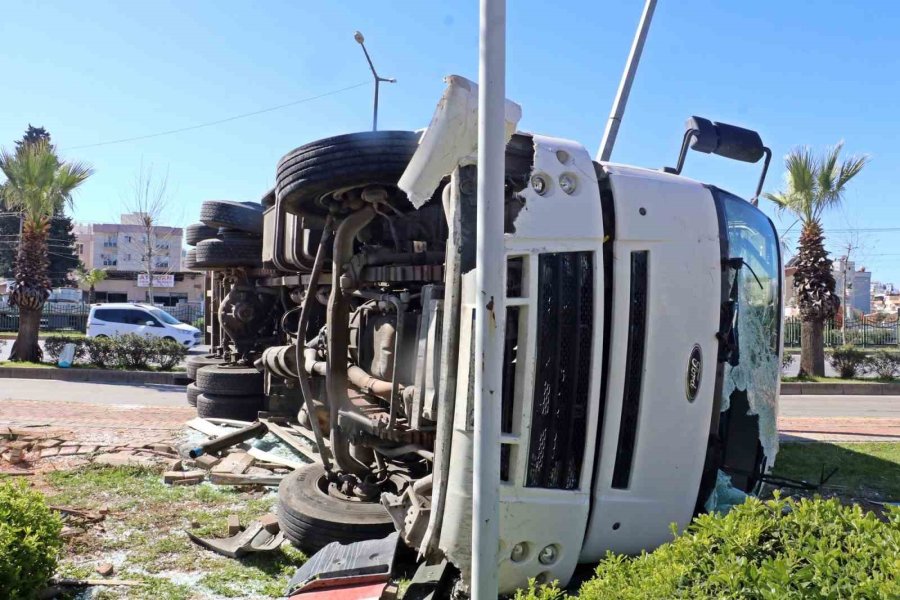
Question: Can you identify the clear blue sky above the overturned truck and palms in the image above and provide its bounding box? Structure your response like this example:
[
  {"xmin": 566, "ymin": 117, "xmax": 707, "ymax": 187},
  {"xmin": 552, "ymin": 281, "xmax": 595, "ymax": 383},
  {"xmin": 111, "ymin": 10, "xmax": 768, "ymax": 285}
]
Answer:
[{"xmin": 0, "ymin": 0, "xmax": 900, "ymax": 284}]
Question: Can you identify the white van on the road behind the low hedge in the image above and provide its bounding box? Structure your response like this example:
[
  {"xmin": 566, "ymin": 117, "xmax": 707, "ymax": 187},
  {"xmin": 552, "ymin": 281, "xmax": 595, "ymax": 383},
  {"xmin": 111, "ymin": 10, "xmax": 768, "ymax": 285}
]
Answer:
[{"xmin": 87, "ymin": 302, "xmax": 201, "ymax": 348}]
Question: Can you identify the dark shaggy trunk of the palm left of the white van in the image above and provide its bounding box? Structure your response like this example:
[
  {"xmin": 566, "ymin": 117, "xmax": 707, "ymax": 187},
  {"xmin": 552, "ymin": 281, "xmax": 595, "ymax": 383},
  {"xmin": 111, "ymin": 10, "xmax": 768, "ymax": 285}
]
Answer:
[{"xmin": 9, "ymin": 219, "xmax": 50, "ymax": 362}]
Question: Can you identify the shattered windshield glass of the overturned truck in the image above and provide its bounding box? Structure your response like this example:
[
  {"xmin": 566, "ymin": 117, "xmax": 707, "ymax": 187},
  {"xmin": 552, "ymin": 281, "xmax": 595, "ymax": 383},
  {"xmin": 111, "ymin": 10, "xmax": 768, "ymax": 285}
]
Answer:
[{"xmin": 719, "ymin": 192, "xmax": 781, "ymax": 466}]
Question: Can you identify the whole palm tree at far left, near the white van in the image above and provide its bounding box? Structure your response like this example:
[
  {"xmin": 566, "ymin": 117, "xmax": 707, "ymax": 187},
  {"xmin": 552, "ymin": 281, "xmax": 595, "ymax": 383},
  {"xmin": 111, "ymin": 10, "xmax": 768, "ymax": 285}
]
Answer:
[{"xmin": 0, "ymin": 140, "xmax": 93, "ymax": 361}]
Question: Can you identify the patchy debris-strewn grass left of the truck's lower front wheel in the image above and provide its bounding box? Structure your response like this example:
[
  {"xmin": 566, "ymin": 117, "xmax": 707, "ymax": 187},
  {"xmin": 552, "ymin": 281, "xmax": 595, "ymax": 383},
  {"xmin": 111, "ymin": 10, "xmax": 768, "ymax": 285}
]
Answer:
[{"xmin": 45, "ymin": 466, "xmax": 306, "ymax": 600}]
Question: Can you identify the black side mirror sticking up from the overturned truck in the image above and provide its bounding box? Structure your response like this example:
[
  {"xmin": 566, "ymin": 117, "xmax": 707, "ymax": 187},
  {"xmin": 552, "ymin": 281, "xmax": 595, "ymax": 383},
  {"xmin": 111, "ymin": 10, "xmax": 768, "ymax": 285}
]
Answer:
[{"xmin": 663, "ymin": 116, "xmax": 772, "ymax": 205}]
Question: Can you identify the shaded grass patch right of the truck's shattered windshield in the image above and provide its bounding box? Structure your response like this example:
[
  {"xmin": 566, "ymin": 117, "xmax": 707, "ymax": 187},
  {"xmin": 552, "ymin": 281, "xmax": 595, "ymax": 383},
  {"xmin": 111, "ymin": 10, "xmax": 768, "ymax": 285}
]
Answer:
[{"xmin": 773, "ymin": 442, "xmax": 900, "ymax": 502}]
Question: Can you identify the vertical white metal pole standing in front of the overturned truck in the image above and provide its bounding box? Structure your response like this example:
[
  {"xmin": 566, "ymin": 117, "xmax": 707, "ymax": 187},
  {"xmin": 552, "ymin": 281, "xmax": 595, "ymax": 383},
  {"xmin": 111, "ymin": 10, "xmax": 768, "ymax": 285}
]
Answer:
[{"xmin": 472, "ymin": 0, "xmax": 506, "ymax": 600}]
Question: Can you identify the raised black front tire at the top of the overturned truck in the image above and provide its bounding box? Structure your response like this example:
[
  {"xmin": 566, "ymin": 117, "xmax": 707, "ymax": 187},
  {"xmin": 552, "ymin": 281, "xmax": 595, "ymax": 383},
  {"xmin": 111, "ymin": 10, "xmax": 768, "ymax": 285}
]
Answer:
[{"xmin": 275, "ymin": 131, "xmax": 419, "ymax": 216}]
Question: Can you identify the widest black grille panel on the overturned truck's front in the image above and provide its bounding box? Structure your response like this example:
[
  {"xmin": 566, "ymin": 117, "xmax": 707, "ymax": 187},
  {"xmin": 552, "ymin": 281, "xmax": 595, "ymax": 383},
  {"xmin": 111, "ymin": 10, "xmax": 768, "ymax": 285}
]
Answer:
[{"xmin": 525, "ymin": 252, "xmax": 594, "ymax": 490}]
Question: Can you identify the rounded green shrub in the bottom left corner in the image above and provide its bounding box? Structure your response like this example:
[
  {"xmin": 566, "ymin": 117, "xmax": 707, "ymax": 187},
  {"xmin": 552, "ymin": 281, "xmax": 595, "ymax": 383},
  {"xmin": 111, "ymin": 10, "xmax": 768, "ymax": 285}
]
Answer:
[{"xmin": 0, "ymin": 481, "xmax": 62, "ymax": 598}]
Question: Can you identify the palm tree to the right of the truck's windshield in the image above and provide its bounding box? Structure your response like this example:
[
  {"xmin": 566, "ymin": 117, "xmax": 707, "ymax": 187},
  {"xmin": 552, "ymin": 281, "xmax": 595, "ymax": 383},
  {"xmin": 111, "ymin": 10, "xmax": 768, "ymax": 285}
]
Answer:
[{"xmin": 765, "ymin": 142, "xmax": 869, "ymax": 376}]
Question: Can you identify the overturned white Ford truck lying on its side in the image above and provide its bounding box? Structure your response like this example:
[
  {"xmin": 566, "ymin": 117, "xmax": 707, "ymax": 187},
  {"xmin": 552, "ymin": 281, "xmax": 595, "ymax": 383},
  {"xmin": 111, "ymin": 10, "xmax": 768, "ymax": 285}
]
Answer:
[{"xmin": 185, "ymin": 78, "xmax": 782, "ymax": 592}]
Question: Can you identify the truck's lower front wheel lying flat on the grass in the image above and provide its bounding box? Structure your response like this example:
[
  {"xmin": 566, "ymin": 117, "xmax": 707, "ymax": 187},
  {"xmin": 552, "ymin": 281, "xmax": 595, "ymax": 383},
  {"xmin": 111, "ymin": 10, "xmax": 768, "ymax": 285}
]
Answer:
[{"xmin": 278, "ymin": 463, "xmax": 394, "ymax": 554}]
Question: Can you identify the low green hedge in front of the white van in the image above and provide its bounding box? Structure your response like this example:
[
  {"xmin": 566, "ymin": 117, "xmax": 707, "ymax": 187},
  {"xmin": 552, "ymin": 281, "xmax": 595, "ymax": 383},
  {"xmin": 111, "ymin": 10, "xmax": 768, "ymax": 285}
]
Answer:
[{"xmin": 44, "ymin": 333, "xmax": 187, "ymax": 371}]
